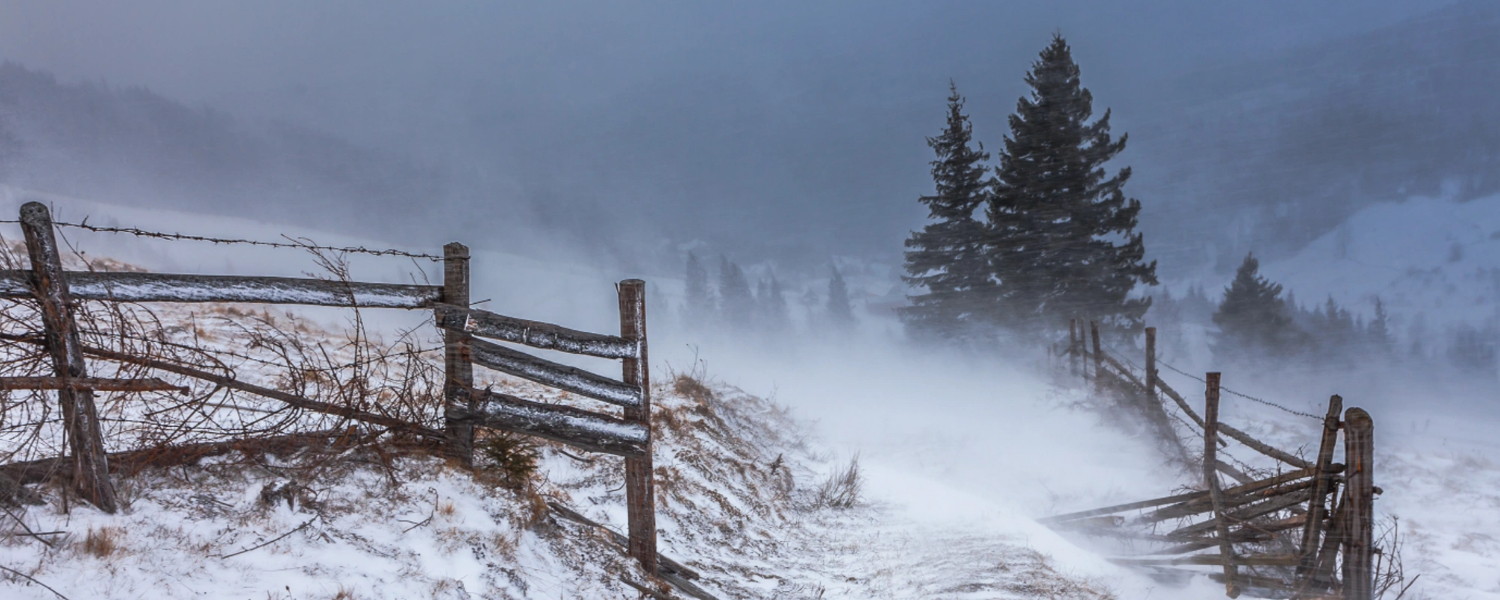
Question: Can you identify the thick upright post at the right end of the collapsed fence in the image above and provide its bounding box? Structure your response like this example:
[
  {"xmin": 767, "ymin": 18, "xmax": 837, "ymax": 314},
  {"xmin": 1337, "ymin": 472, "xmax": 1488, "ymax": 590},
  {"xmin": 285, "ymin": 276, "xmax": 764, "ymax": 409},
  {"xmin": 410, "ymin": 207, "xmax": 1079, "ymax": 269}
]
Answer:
[{"xmin": 1344, "ymin": 408, "xmax": 1376, "ymax": 600}]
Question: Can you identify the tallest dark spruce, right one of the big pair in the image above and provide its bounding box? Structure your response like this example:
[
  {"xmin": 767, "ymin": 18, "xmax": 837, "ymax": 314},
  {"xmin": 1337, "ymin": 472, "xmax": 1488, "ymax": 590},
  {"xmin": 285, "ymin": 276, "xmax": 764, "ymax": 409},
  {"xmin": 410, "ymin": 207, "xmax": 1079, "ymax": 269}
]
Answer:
[{"xmin": 986, "ymin": 35, "xmax": 1157, "ymax": 332}]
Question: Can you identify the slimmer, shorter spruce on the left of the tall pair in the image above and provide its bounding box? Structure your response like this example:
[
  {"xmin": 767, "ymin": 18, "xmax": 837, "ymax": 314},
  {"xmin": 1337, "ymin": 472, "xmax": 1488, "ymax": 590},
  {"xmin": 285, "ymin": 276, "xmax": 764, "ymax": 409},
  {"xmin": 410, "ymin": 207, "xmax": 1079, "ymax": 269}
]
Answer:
[{"xmin": 900, "ymin": 81, "xmax": 993, "ymax": 339}]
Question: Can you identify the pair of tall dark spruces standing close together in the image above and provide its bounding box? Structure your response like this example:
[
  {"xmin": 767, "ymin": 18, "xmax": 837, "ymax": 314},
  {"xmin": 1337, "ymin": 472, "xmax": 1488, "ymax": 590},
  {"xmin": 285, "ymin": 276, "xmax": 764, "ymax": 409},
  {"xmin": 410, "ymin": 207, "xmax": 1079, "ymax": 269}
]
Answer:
[{"xmin": 900, "ymin": 35, "xmax": 1157, "ymax": 341}]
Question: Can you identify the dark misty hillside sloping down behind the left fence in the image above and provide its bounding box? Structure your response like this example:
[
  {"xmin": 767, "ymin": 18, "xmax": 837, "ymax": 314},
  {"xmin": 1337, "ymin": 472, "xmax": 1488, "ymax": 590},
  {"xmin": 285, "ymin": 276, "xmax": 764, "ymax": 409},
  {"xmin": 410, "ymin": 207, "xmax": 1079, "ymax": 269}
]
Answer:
[{"xmin": 0, "ymin": 62, "xmax": 447, "ymax": 243}]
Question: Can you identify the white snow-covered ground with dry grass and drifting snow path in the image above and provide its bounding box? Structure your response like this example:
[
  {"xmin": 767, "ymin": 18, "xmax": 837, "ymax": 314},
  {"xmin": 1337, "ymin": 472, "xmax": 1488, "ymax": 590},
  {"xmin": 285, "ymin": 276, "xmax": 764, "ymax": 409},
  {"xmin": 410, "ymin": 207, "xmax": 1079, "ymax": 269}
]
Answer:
[{"xmin": 0, "ymin": 194, "xmax": 1500, "ymax": 600}]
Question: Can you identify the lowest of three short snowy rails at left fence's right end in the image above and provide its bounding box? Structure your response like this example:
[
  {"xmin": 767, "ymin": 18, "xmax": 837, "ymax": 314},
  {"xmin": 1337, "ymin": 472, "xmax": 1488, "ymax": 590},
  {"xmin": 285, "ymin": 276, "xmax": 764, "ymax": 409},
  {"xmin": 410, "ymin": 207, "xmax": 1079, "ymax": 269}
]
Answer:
[{"xmin": 459, "ymin": 390, "xmax": 651, "ymax": 458}]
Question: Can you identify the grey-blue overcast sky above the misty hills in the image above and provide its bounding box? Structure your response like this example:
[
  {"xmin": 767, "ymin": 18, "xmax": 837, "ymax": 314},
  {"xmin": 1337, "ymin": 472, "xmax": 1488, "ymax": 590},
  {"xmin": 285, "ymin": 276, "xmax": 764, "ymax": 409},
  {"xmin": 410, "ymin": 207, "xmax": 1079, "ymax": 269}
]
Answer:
[{"xmin": 0, "ymin": 0, "xmax": 1464, "ymax": 267}]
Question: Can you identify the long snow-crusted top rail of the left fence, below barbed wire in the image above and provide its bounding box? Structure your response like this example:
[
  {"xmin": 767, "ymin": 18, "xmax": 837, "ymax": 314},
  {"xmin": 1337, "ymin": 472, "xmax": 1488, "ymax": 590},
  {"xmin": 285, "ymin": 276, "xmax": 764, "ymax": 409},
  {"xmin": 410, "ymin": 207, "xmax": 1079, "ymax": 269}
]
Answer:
[{"xmin": 0, "ymin": 272, "xmax": 443, "ymax": 309}]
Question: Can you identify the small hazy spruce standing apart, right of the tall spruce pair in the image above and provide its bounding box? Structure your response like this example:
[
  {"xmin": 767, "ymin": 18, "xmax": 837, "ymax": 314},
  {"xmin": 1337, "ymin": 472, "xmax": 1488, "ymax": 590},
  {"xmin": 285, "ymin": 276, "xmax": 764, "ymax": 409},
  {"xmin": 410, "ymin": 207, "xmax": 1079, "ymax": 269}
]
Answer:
[{"xmin": 1214, "ymin": 254, "xmax": 1298, "ymax": 359}]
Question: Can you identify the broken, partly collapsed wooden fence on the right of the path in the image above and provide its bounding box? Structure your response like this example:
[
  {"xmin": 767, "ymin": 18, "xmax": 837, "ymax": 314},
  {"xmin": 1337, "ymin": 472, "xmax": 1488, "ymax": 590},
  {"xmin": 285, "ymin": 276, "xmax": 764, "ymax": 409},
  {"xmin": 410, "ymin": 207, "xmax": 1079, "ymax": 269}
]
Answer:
[{"xmin": 1041, "ymin": 321, "xmax": 1380, "ymax": 600}]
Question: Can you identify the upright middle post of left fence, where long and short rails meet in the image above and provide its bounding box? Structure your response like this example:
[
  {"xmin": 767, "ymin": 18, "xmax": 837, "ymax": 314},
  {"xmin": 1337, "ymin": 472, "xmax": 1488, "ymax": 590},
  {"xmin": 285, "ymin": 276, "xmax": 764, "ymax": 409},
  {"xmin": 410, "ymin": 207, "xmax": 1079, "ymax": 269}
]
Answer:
[{"xmin": 443, "ymin": 242, "xmax": 479, "ymax": 467}]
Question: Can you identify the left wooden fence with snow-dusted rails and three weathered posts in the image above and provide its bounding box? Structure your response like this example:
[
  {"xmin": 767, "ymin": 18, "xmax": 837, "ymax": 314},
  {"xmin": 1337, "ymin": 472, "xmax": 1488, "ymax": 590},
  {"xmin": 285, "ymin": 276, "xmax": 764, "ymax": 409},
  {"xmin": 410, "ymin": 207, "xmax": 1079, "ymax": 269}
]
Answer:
[{"xmin": 0, "ymin": 203, "xmax": 663, "ymax": 576}]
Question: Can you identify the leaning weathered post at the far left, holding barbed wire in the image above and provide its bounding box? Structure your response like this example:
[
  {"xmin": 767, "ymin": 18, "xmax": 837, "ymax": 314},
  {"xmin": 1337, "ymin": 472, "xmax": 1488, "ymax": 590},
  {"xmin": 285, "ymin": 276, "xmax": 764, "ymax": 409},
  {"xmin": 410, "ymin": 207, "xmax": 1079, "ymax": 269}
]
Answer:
[{"xmin": 21, "ymin": 203, "xmax": 117, "ymax": 513}]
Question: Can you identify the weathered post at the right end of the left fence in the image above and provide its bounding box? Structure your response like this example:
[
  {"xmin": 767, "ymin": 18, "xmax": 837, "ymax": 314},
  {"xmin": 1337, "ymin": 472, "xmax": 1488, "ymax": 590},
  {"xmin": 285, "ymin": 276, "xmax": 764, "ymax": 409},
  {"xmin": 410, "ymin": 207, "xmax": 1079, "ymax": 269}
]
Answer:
[{"xmin": 620, "ymin": 279, "xmax": 657, "ymax": 575}]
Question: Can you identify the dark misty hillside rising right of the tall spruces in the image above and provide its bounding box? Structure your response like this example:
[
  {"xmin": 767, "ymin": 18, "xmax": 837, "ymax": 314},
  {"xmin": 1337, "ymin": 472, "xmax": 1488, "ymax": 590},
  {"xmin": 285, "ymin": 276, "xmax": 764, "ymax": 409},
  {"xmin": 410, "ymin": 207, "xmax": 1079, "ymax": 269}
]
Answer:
[{"xmin": 1128, "ymin": 2, "xmax": 1500, "ymax": 272}]
